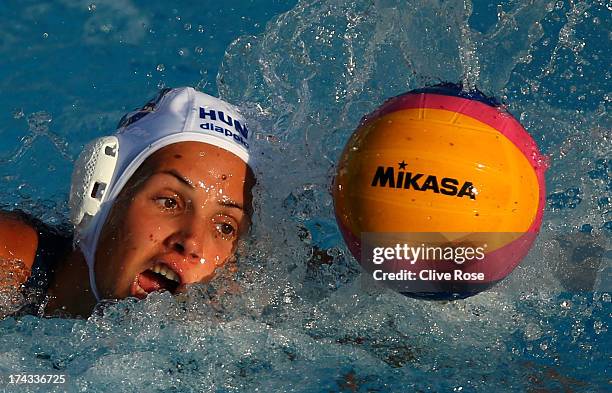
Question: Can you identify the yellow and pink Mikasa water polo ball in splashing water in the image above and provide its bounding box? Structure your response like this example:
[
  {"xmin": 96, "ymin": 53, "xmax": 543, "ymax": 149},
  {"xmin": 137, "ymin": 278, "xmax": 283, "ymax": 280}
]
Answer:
[{"xmin": 333, "ymin": 86, "xmax": 546, "ymax": 298}]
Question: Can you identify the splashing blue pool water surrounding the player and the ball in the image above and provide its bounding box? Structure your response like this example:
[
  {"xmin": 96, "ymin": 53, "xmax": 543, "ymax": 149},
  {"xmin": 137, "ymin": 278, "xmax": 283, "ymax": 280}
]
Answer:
[{"xmin": 0, "ymin": 0, "xmax": 612, "ymax": 392}]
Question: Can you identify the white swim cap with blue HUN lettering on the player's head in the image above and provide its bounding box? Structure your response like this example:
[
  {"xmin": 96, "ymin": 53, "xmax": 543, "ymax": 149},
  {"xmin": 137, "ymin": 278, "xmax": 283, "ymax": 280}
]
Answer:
[{"xmin": 69, "ymin": 87, "xmax": 252, "ymax": 300}]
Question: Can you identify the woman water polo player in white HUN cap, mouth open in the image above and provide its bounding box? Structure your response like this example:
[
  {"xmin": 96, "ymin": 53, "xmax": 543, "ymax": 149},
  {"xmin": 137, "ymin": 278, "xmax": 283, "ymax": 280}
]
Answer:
[{"xmin": 0, "ymin": 88, "xmax": 255, "ymax": 316}]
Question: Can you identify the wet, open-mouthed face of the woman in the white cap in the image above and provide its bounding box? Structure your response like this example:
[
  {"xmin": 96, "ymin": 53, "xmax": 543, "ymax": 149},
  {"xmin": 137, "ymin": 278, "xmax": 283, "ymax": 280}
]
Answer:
[{"xmin": 95, "ymin": 142, "xmax": 254, "ymax": 299}]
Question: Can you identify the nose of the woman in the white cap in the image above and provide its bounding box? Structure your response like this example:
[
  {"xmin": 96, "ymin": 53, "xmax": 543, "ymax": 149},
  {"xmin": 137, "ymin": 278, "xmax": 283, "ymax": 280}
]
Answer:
[{"xmin": 169, "ymin": 213, "xmax": 206, "ymax": 262}]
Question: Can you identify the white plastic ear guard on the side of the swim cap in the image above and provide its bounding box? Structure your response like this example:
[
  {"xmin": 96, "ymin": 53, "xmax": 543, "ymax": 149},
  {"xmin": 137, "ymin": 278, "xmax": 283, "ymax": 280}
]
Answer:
[{"xmin": 68, "ymin": 136, "xmax": 119, "ymax": 233}]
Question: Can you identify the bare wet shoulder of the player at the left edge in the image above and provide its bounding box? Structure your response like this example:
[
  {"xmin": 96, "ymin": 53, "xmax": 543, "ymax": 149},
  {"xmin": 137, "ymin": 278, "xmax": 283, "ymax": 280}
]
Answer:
[{"xmin": 0, "ymin": 211, "xmax": 38, "ymax": 269}]
